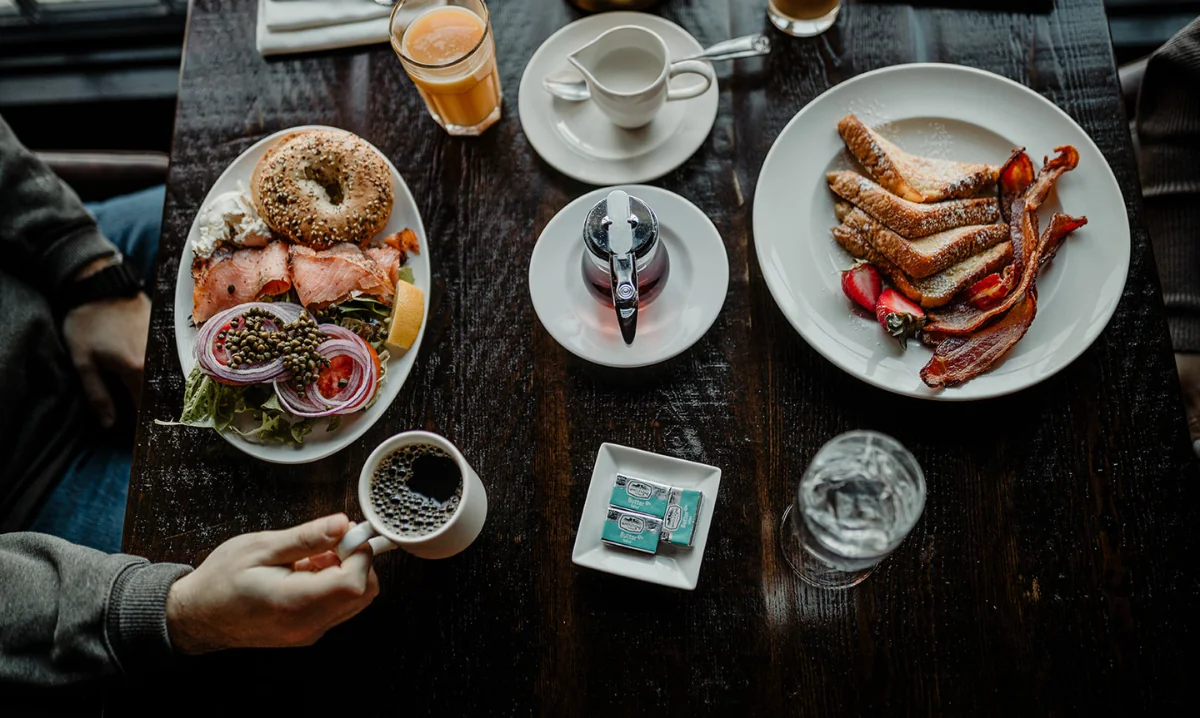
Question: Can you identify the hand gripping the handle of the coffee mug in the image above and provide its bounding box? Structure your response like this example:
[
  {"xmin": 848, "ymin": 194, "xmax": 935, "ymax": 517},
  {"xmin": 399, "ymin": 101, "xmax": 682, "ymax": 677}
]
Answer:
[{"xmin": 167, "ymin": 514, "xmax": 379, "ymax": 654}]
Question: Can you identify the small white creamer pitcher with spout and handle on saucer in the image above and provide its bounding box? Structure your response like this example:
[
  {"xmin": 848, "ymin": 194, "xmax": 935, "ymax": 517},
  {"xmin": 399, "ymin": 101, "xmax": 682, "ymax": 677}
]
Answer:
[{"xmin": 566, "ymin": 25, "xmax": 716, "ymax": 130}]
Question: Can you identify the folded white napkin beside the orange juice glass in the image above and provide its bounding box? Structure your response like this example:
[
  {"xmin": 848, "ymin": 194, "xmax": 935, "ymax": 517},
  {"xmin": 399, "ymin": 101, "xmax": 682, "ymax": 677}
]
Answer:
[{"xmin": 254, "ymin": 0, "xmax": 420, "ymax": 55}]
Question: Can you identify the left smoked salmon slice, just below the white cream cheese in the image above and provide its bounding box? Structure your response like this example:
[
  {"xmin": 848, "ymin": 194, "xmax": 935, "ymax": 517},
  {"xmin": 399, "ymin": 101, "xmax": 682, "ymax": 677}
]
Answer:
[{"xmin": 192, "ymin": 241, "xmax": 292, "ymax": 324}]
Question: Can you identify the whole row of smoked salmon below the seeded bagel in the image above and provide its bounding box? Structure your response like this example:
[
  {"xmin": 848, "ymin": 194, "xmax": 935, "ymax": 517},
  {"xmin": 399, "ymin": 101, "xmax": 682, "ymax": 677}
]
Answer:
[{"xmin": 192, "ymin": 229, "xmax": 419, "ymax": 324}]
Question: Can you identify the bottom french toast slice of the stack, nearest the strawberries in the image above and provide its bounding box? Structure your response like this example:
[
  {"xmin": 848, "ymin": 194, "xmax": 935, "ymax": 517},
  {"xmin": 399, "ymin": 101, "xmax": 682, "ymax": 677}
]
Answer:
[{"xmin": 832, "ymin": 219, "xmax": 1013, "ymax": 309}]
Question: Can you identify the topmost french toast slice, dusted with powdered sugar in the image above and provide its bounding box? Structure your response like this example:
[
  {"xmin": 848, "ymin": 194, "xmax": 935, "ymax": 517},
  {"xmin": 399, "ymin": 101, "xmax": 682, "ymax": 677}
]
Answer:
[{"xmin": 838, "ymin": 114, "xmax": 1000, "ymax": 202}]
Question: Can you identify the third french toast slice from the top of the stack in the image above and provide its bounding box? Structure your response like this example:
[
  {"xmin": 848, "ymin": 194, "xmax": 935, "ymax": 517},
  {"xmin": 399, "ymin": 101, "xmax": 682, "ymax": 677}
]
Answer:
[{"xmin": 836, "ymin": 203, "xmax": 1008, "ymax": 279}]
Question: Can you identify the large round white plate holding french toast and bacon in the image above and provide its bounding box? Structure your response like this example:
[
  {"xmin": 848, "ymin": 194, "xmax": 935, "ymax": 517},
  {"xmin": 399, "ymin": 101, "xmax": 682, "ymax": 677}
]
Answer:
[{"xmin": 754, "ymin": 64, "xmax": 1129, "ymax": 401}]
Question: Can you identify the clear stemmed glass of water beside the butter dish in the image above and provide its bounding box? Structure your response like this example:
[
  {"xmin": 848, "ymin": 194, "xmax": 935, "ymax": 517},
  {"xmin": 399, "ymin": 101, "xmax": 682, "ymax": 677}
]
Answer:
[{"xmin": 779, "ymin": 431, "xmax": 925, "ymax": 588}]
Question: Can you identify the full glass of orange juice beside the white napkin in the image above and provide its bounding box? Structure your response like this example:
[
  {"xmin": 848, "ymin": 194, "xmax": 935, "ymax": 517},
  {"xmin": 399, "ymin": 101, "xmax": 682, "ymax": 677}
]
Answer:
[{"xmin": 390, "ymin": 0, "xmax": 504, "ymax": 137}]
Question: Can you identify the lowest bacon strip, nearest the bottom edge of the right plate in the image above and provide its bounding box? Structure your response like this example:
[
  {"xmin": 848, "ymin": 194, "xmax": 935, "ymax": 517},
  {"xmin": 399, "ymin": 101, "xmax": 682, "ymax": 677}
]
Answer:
[{"xmin": 920, "ymin": 289, "xmax": 1038, "ymax": 389}]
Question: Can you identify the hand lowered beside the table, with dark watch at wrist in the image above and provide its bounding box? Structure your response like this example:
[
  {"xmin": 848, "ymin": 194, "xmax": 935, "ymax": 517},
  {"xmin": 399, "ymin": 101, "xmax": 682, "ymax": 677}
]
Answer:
[{"xmin": 62, "ymin": 259, "xmax": 150, "ymax": 429}]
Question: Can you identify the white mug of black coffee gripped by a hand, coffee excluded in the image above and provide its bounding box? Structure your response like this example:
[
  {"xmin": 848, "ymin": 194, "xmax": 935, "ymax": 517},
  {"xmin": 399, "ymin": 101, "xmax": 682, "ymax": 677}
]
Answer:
[{"xmin": 337, "ymin": 431, "xmax": 487, "ymax": 558}]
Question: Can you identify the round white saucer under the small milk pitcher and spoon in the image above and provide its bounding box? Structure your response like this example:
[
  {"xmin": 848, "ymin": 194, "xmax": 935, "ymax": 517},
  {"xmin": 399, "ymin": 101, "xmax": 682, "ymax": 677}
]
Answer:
[{"xmin": 517, "ymin": 12, "xmax": 719, "ymax": 185}]
